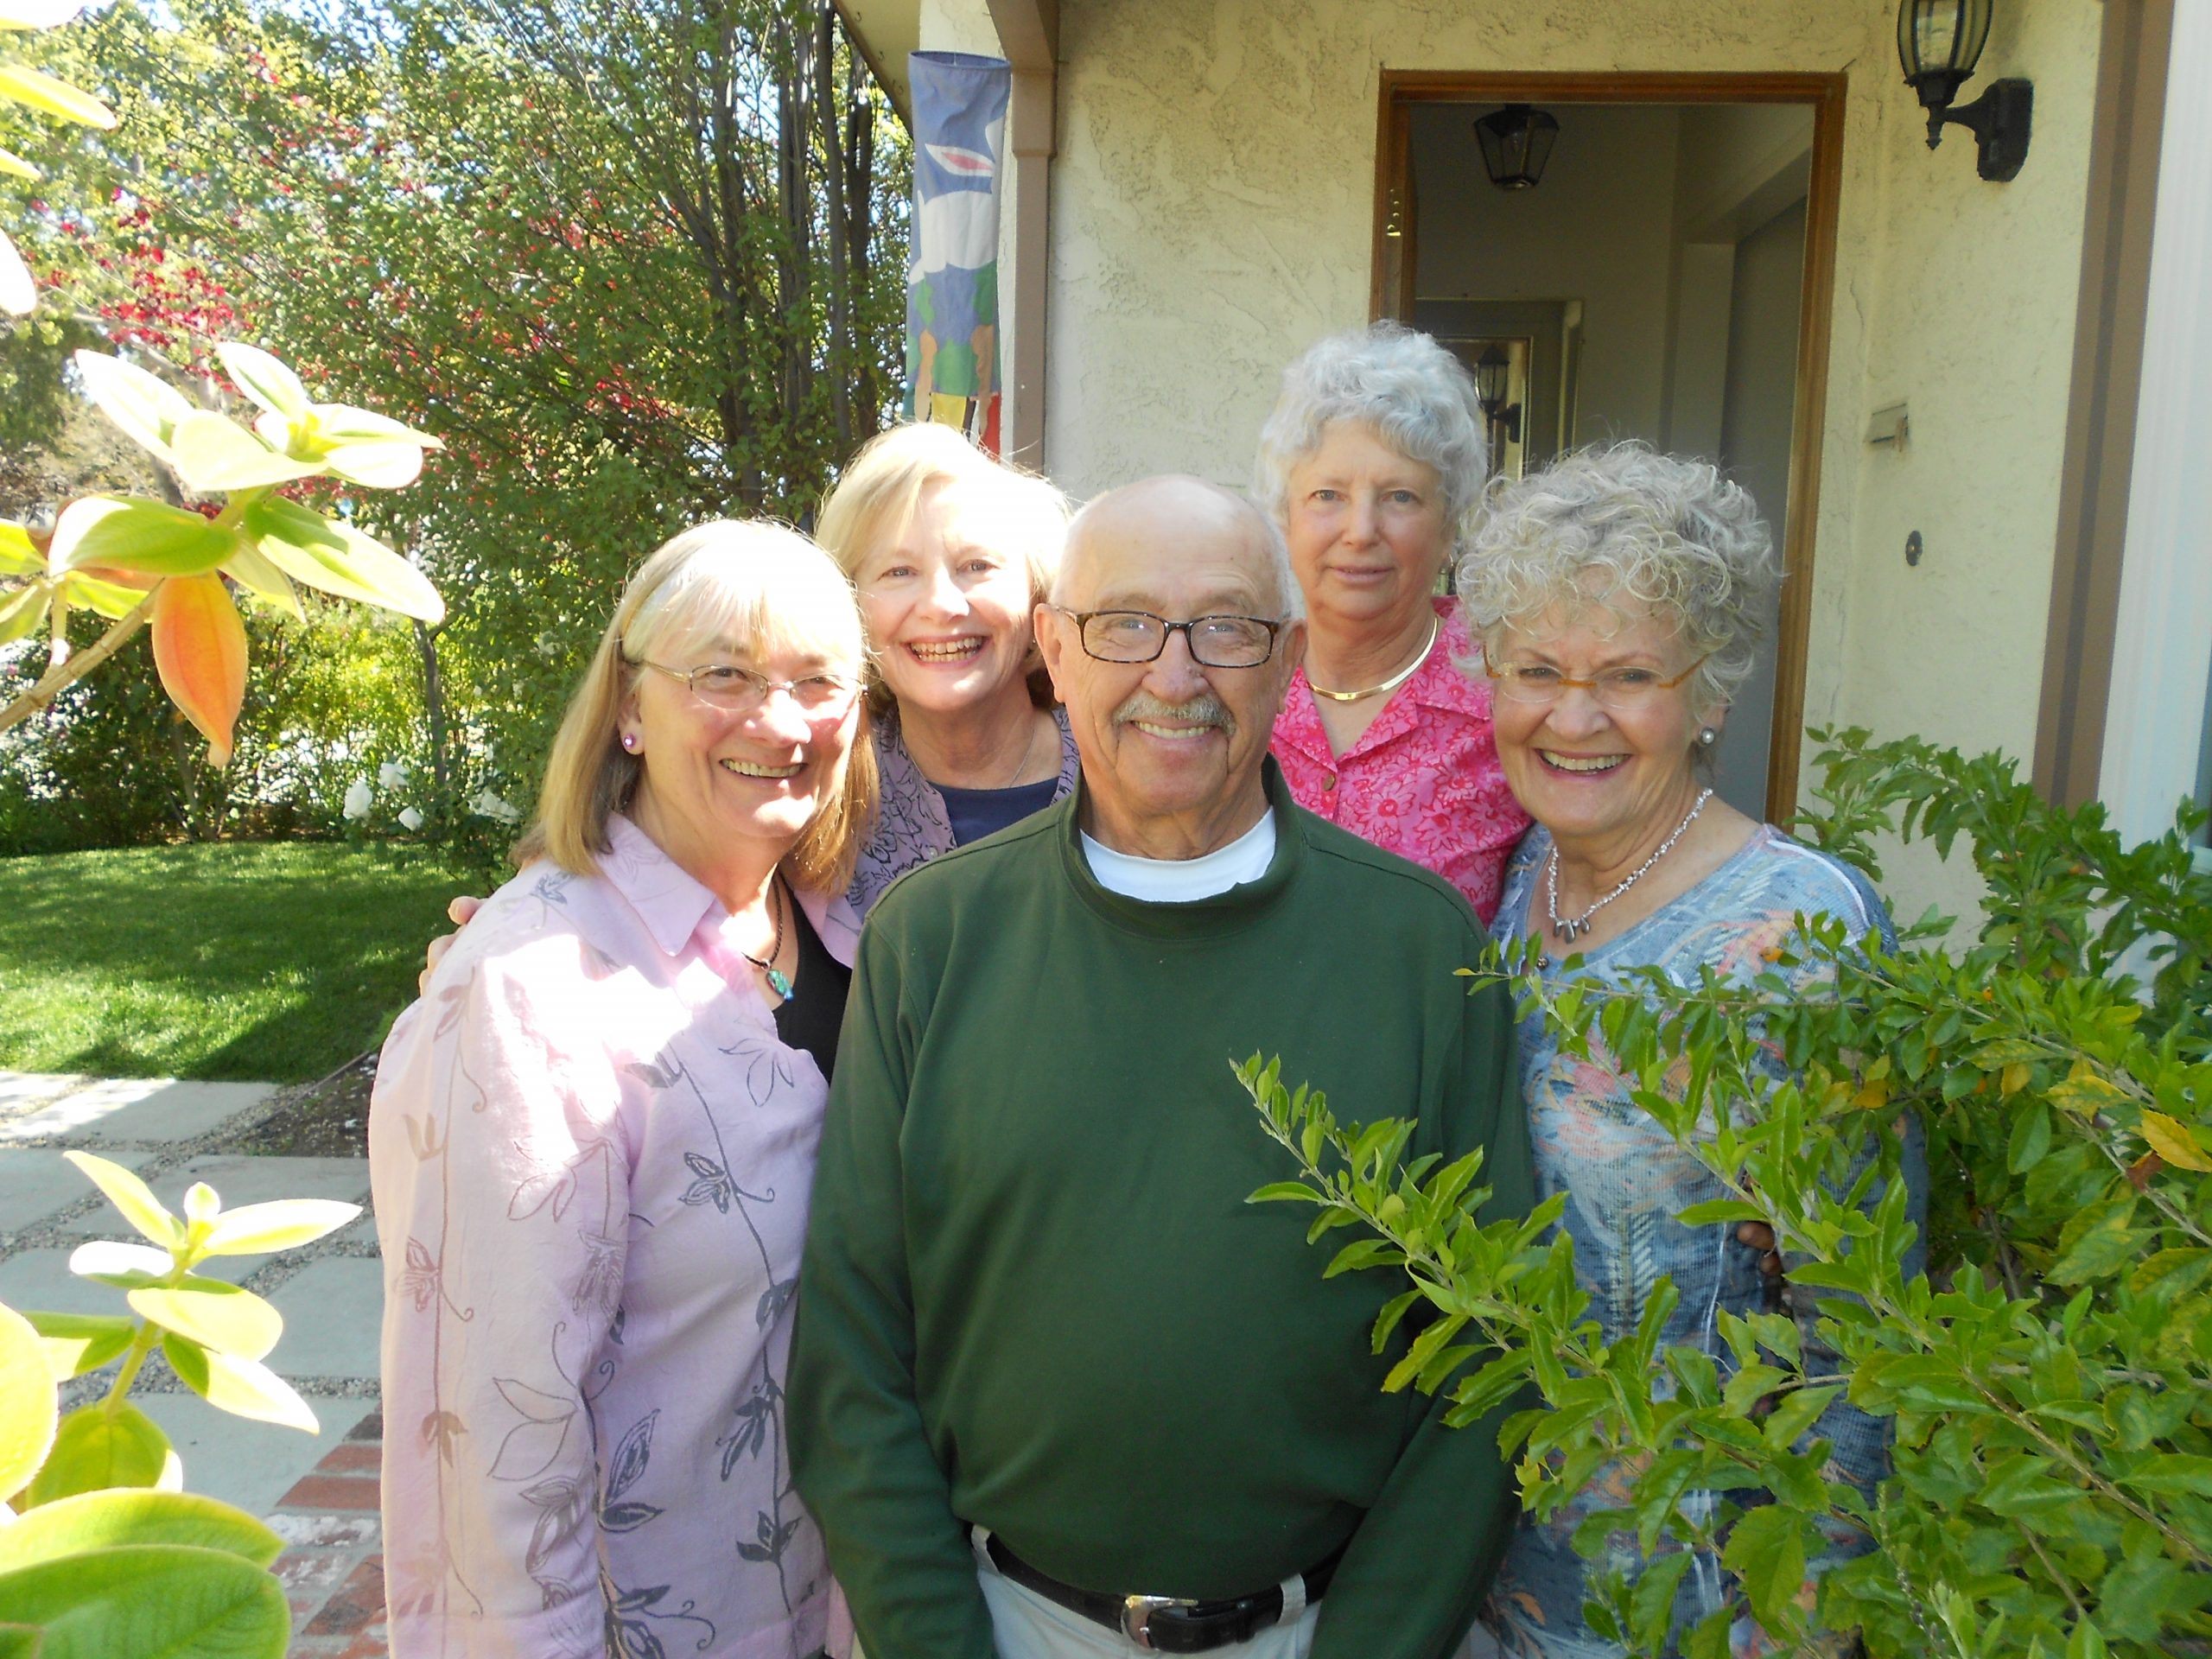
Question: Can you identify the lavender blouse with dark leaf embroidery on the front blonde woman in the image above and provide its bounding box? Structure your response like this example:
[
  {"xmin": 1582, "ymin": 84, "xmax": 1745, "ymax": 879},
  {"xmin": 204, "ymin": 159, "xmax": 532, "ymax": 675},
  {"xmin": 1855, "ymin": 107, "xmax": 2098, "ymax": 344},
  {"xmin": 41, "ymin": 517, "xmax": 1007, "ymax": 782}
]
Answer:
[{"xmin": 370, "ymin": 818, "xmax": 856, "ymax": 1659}]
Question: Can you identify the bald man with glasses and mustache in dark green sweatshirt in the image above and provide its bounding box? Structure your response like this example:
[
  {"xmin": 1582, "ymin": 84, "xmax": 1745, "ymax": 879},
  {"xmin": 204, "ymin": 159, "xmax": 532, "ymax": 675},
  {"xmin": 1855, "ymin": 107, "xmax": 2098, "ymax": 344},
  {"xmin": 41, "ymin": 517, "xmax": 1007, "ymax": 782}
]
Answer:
[{"xmin": 790, "ymin": 478, "xmax": 1531, "ymax": 1659}]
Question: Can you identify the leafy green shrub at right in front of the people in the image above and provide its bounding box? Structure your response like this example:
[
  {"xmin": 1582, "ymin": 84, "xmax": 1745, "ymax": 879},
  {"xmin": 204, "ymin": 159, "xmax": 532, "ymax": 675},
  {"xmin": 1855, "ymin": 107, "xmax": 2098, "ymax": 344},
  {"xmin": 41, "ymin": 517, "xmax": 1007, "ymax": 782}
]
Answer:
[{"xmin": 1239, "ymin": 730, "xmax": 2212, "ymax": 1659}]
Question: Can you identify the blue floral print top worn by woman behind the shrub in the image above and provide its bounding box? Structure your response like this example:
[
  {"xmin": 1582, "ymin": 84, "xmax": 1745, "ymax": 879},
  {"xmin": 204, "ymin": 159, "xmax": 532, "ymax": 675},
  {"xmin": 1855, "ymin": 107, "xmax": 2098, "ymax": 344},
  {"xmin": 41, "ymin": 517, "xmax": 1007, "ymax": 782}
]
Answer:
[{"xmin": 1484, "ymin": 825, "xmax": 1927, "ymax": 1659}]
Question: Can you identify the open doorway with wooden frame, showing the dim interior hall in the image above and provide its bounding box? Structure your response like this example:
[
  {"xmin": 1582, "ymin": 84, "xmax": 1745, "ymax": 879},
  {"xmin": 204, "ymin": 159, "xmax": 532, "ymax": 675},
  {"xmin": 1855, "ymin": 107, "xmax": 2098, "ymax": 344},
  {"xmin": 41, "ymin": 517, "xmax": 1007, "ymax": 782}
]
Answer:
[{"xmin": 1374, "ymin": 71, "xmax": 1842, "ymax": 821}]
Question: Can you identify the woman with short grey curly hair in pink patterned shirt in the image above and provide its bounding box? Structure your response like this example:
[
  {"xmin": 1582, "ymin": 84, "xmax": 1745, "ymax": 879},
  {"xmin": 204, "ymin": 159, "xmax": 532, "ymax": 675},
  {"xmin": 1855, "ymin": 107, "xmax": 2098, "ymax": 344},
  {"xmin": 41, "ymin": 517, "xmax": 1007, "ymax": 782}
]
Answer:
[{"xmin": 1255, "ymin": 323, "xmax": 1529, "ymax": 923}]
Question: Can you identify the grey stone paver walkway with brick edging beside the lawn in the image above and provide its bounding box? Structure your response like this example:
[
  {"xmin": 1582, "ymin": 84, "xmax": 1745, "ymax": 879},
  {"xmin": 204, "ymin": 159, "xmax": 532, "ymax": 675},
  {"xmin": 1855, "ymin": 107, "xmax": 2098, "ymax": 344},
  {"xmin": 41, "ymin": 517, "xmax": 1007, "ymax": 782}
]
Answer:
[{"xmin": 0, "ymin": 1071, "xmax": 385, "ymax": 1659}]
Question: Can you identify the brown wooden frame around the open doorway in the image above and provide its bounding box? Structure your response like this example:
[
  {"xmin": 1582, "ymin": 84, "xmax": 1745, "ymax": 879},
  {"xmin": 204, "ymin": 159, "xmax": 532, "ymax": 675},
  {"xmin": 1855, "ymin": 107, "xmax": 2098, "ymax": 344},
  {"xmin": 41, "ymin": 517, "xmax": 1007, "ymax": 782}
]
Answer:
[{"xmin": 1367, "ymin": 68, "xmax": 1847, "ymax": 823}]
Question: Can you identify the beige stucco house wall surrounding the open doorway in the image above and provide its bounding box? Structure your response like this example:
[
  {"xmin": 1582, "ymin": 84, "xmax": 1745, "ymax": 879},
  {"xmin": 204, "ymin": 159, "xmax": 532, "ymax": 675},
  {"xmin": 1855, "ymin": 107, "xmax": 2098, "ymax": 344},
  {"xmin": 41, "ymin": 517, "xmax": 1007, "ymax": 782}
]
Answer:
[{"xmin": 893, "ymin": 0, "xmax": 2101, "ymax": 902}]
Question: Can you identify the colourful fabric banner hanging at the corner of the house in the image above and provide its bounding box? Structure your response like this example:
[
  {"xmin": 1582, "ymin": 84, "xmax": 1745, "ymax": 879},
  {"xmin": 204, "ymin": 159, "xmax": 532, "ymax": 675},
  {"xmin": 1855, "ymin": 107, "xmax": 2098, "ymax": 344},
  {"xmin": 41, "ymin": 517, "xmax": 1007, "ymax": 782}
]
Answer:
[{"xmin": 907, "ymin": 51, "xmax": 1013, "ymax": 455}]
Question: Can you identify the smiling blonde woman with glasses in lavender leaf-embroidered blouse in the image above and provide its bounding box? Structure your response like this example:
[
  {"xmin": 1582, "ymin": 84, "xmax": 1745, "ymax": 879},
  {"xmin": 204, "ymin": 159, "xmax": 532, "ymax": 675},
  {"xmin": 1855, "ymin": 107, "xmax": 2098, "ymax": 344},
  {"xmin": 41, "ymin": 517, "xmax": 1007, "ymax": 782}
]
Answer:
[{"xmin": 370, "ymin": 522, "xmax": 876, "ymax": 1659}]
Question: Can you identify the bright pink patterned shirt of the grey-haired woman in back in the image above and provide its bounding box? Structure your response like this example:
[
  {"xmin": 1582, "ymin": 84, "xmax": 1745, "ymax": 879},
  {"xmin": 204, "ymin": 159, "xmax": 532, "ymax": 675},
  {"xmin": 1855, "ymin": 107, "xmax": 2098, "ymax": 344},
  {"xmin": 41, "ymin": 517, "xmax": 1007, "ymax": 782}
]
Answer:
[{"xmin": 1272, "ymin": 600, "xmax": 1529, "ymax": 925}]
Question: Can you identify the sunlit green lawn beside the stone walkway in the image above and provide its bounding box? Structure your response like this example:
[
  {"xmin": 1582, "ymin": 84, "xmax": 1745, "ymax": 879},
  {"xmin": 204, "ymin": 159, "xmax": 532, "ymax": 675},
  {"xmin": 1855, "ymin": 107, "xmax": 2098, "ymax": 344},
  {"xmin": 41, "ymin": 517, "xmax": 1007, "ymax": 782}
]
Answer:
[{"xmin": 0, "ymin": 841, "xmax": 471, "ymax": 1082}]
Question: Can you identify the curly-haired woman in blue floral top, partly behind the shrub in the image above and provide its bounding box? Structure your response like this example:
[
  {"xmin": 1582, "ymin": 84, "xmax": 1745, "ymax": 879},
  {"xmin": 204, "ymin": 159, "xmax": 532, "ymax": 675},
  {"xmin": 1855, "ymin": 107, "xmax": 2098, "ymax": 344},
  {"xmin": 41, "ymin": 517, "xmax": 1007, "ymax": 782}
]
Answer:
[{"xmin": 1460, "ymin": 445, "xmax": 1927, "ymax": 1659}]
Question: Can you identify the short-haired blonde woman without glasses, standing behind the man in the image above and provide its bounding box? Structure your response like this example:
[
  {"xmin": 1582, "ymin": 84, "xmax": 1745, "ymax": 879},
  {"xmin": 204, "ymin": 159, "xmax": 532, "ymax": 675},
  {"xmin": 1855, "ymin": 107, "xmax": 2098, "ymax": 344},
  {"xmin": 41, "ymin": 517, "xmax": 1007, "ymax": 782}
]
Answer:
[{"xmin": 817, "ymin": 423, "xmax": 1075, "ymax": 916}]
